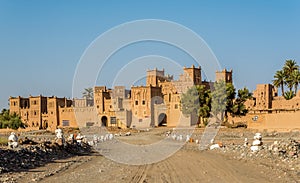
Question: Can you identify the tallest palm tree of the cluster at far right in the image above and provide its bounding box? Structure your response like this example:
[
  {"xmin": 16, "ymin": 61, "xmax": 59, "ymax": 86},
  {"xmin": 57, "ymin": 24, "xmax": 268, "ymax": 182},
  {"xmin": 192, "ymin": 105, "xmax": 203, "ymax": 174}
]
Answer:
[{"xmin": 283, "ymin": 60, "xmax": 299, "ymax": 91}]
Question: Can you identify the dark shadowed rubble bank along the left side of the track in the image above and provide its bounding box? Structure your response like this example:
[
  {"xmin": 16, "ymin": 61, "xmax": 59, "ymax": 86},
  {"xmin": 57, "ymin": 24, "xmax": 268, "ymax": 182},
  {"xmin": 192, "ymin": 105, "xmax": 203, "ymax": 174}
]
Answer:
[{"xmin": 0, "ymin": 141, "xmax": 91, "ymax": 173}]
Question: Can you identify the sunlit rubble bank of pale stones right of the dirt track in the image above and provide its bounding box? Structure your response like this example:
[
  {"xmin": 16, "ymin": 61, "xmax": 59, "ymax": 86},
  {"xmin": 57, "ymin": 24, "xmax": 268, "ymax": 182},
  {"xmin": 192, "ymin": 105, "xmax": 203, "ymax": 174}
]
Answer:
[{"xmin": 219, "ymin": 139, "xmax": 300, "ymax": 176}]
